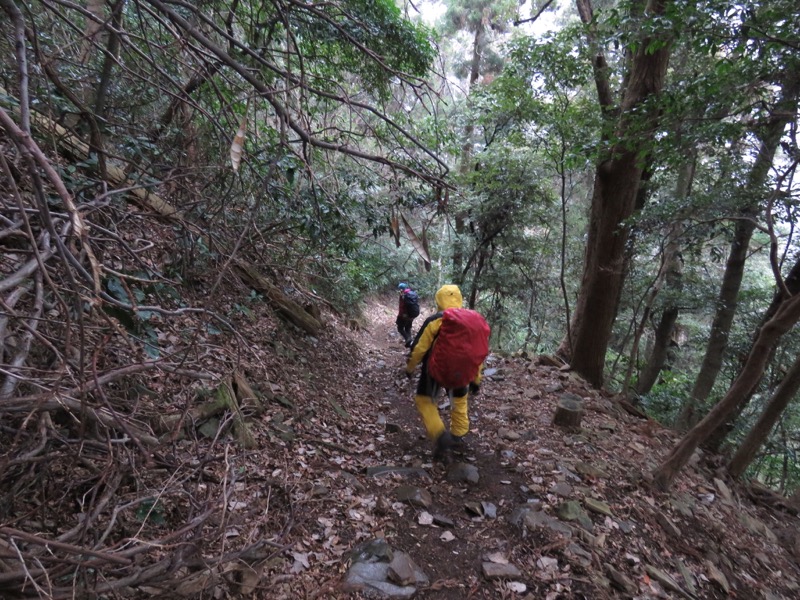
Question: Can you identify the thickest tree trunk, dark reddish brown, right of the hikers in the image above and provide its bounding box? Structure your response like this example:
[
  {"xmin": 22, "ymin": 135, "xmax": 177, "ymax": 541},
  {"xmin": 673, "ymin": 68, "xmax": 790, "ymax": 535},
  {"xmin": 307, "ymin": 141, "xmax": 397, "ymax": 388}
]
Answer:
[{"xmin": 559, "ymin": 0, "xmax": 670, "ymax": 387}]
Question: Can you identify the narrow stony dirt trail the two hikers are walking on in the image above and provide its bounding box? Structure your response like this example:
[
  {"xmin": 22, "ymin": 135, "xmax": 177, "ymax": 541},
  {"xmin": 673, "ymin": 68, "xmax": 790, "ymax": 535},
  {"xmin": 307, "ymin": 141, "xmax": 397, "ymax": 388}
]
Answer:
[{"xmin": 350, "ymin": 298, "xmax": 580, "ymax": 600}]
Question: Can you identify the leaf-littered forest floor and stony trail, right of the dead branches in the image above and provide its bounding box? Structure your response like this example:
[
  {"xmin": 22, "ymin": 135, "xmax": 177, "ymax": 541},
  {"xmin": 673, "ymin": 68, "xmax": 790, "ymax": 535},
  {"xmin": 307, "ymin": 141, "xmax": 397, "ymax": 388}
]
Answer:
[{"xmin": 180, "ymin": 295, "xmax": 800, "ymax": 600}]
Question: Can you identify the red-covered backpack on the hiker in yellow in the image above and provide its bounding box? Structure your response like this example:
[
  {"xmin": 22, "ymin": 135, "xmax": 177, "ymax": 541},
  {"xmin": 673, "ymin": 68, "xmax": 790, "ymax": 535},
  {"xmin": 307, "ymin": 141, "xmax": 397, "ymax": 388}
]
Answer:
[{"xmin": 428, "ymin": 308, "xmax": 491, "ymax": 390}]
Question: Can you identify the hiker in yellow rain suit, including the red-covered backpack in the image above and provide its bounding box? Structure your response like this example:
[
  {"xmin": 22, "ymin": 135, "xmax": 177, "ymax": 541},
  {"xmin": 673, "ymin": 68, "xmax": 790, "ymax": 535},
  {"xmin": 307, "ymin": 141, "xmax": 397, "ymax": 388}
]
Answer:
[{"xmin": 406, "ymin": 285, "xmax": 490, "ymax": 460}]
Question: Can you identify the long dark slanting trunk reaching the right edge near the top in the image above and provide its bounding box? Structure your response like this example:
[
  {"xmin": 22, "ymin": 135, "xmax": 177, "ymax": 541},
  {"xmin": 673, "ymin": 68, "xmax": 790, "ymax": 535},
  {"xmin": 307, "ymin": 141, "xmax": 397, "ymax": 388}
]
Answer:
[{"xmin": 676, "ymin": 72, "xmax": 800, "ymax": 429}]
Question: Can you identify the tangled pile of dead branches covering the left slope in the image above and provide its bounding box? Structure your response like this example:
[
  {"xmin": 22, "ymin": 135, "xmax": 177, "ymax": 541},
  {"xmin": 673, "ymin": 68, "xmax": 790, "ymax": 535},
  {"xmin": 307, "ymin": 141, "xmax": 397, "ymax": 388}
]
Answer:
[{"xmin": 0, "ymin": 101, "xmax": 296, "ymax": 598}]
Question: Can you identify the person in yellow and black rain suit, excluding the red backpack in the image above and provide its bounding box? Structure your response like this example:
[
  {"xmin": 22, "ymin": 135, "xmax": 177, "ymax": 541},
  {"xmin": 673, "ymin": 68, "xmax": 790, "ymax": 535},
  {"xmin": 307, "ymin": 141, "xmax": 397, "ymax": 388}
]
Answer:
[{"xmin": 406, "ymin": 285, "xmax": 483, "ymax": 459}]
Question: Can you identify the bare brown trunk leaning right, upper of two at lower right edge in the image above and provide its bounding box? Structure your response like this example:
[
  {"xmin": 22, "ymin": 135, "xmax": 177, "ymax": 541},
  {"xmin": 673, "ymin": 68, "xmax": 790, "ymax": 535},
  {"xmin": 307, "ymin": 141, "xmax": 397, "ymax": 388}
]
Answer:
[{"xmin": 653, "ymin": 296, "xmax": 800, "ymax": 491}]
